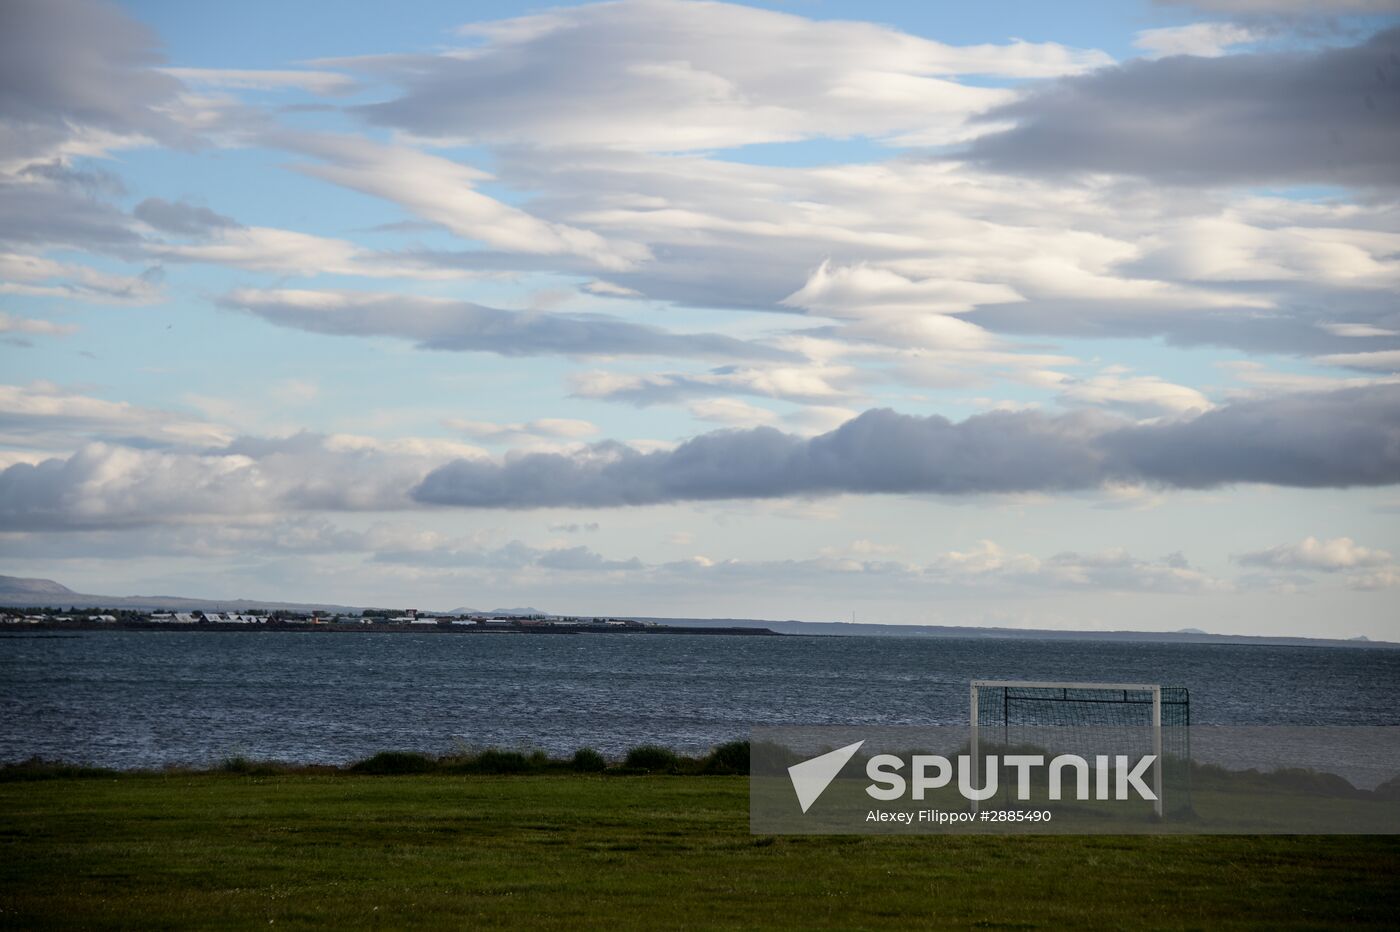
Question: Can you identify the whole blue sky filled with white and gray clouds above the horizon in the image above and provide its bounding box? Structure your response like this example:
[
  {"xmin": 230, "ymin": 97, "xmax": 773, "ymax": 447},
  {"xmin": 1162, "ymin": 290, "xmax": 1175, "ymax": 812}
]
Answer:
[{"xmin": 0, "ymin": 0, "xmax": 1400, "ymax": 640}]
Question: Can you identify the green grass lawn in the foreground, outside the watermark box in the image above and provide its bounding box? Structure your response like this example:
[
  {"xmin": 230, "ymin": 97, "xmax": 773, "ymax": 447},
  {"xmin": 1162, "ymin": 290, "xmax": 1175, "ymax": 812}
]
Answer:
[{"xmin": 0, "ymin": 772, "xmax": 1400, "ymax": 929}]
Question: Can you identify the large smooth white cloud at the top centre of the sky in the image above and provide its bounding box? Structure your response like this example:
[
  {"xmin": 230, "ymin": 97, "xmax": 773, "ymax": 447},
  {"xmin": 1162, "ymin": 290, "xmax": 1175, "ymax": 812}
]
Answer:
[{"xmin": 329, "ymin": 0, "xmax": 1112, "ymax": 151}]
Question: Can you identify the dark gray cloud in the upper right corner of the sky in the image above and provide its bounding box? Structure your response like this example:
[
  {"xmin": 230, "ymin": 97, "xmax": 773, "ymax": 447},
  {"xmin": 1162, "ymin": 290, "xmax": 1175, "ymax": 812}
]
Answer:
[{"xmin": 967, "ymin": 28, "xmax": 1400, "ymax": 186}]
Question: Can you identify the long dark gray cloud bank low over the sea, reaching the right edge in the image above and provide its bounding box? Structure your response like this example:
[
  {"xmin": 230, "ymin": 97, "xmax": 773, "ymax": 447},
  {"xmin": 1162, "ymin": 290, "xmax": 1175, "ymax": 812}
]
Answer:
[{"xmin": 412, "ymin": 385, "xmax": 1400, "ymax": 508}]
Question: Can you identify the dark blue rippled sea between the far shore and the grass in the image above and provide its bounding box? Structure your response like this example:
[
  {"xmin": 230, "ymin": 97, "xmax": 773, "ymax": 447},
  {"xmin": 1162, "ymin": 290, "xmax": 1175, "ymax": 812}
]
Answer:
[{"xmin": 0, "ymin": 631, "xmax": 1400, "ymax": 767}]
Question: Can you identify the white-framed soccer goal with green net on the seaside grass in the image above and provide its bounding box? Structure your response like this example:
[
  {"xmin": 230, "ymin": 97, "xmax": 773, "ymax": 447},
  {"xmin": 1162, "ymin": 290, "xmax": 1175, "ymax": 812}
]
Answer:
[{"xmin": 969, "ymin": 680, "xmax": 1191, "ymax": 817}]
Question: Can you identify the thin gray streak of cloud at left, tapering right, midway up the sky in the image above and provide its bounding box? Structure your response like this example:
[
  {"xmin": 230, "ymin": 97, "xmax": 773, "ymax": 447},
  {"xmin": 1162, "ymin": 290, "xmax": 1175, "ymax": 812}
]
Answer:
[{"xmin": 220, "ymin": 290, "xmax": 787, "ymax": 360}]
